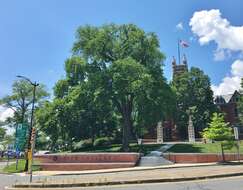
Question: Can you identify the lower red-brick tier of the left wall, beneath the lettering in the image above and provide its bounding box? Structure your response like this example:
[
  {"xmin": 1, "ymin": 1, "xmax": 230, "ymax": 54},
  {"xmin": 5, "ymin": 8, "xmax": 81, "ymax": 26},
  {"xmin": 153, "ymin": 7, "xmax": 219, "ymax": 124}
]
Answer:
[{"xmin": 40, "ymin": 162, "xmax": 136, "ymax": 171}]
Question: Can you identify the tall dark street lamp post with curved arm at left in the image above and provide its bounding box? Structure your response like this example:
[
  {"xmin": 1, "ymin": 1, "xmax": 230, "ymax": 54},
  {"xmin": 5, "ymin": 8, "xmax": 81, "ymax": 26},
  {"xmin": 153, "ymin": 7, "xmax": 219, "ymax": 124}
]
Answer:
[{"xmin": 17, "ymin": 75, "xmax": 39, "ymax": 182}]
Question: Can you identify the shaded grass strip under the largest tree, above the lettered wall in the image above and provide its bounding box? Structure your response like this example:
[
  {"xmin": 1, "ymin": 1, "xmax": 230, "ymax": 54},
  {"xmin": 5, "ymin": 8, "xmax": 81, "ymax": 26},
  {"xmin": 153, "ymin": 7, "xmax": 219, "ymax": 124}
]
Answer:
[{"xmin": 72, "ymin": 143, "xmax": 163, "ymax": 155}]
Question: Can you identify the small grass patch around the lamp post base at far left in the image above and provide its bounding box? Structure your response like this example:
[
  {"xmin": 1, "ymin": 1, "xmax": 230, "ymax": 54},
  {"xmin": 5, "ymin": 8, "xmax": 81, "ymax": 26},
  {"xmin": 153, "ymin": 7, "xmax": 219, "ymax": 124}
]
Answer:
[{"xmin": 2, "ymin": 159, "xmax": 40, "ymax": 173}]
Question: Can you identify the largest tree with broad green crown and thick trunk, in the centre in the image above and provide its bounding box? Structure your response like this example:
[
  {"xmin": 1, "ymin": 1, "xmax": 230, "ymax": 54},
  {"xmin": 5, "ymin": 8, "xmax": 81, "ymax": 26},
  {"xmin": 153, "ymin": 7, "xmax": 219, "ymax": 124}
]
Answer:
[{"xmin": 37, "ymin": 24, "xmax": 173, "ymax": 150}]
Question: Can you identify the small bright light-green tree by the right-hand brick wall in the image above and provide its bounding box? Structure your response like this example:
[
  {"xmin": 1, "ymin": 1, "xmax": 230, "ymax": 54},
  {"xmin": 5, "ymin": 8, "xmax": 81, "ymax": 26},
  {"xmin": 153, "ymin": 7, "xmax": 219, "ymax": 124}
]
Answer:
[{"xmin": 203, "ymin": 113, "xmax": 234, "ymax": 162}]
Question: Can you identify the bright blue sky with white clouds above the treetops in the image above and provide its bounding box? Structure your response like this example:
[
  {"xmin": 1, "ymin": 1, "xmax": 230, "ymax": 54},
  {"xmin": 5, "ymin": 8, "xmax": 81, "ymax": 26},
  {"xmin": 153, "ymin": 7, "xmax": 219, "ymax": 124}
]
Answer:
[{"xmin": 0, "ymin": 0, "xmax": 243, "ymax": 97}]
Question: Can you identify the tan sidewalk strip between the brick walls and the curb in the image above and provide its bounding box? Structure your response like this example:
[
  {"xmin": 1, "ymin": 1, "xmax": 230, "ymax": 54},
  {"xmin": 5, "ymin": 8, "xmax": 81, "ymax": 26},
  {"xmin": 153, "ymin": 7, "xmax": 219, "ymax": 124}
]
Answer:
[{"xmin": 11, "ymin": 164, "xmax": 243, "ymax": 188}]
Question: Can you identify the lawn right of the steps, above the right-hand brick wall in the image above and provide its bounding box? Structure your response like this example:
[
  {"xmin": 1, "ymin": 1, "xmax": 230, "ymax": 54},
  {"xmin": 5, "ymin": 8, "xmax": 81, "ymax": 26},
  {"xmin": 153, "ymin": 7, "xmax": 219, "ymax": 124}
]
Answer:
[{"xmin": 167, "ymin": 141, "xmax": 243, "ymax": 153}]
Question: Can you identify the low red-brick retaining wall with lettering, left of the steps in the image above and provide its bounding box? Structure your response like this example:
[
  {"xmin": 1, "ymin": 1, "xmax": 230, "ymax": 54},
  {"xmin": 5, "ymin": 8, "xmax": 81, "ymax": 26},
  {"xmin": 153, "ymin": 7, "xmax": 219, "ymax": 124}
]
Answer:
[{"xmin": 35, "ymin": 153, "xmax": 140, "ymax": 171}]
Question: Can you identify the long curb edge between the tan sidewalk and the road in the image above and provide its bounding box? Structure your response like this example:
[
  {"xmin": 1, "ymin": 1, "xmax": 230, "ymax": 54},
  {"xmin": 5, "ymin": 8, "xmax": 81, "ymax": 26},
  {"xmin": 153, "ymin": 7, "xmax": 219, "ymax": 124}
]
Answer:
[{"xmin": 7, "ymin": 172, "xmax": 243, "ymax": 189}]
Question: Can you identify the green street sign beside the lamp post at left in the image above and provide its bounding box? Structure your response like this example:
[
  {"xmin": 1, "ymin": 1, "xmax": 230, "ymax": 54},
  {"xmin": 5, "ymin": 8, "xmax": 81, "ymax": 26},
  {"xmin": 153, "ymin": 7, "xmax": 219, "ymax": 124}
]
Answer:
[{"xmin": 15, "ymin": 124, "xmax": 28, "ymax": 151}]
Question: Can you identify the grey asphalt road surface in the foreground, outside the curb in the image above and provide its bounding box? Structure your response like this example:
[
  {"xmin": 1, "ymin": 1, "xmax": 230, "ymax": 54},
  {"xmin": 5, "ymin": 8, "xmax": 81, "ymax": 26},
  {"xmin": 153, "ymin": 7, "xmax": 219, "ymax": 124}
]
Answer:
[{"xmin": 0, "ymin": 174, "xmax": 243, "ymax": 190}]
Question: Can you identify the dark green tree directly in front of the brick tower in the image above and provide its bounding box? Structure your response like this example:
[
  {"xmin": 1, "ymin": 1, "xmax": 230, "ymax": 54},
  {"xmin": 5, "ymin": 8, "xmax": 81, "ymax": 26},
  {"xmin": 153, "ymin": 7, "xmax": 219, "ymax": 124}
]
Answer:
[{"xmin": 172, "ymin": 67, "xmax": 216, "ymax": 138}]
